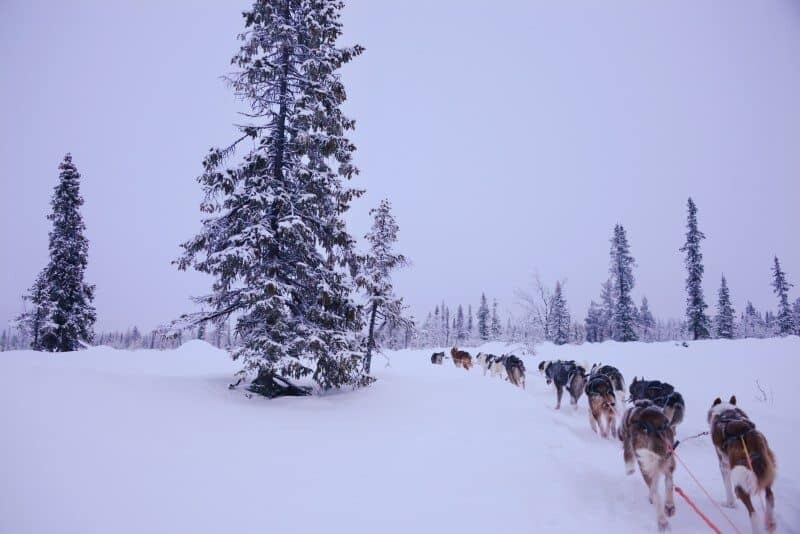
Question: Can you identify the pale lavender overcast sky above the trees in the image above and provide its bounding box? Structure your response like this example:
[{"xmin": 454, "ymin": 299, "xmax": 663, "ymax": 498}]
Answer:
[{"xmin": 0, "ymin": 0, "xmax": 800, "ymax": 330}]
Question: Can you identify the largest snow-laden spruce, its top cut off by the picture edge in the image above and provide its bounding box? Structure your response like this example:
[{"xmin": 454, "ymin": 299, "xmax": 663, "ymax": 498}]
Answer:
[{"xmin": 177, "ymin": 0, "xmax": 369, "ymax": 396}]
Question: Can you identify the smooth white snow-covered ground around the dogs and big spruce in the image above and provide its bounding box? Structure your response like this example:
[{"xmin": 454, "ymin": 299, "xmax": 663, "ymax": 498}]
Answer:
[{"xmin": 0, "ymin": 337, "xmax": 800, "ymax": 534}]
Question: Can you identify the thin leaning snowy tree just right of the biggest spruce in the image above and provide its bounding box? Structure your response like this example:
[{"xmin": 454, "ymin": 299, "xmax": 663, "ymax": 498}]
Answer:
[{"xmin": 356, "ymin": 199, "xmax": 416, "ymax": 374}]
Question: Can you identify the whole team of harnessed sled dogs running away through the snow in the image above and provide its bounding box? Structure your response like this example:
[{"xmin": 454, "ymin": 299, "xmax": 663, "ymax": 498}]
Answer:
[{"xmin": 431, "ymin": 347, "xmax": 776, "ymax": 533}]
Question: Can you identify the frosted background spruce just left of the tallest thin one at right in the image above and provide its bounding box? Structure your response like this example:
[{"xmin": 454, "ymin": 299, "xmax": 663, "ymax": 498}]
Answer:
[{"xmin": 609, "ymin": 224, "xmax": 637, "ymax": 341}]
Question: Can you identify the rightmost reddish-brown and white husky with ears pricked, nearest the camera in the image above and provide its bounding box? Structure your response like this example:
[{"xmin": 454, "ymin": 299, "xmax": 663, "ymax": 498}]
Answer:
[{"xmin": 708, "ymin": 395, "xmax": 777, "ymax": 533}]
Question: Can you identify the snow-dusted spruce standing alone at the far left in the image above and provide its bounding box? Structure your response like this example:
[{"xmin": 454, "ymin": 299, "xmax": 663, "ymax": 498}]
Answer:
[{"xmin": 20, "ymin": 154, "xmax": 96, "ymax": 352}]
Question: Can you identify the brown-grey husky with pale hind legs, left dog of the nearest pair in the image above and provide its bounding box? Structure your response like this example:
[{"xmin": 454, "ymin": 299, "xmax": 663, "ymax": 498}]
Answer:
[{"xmin": 619, "ymin": 400, "xmax": 675, "ymax": 532}]
